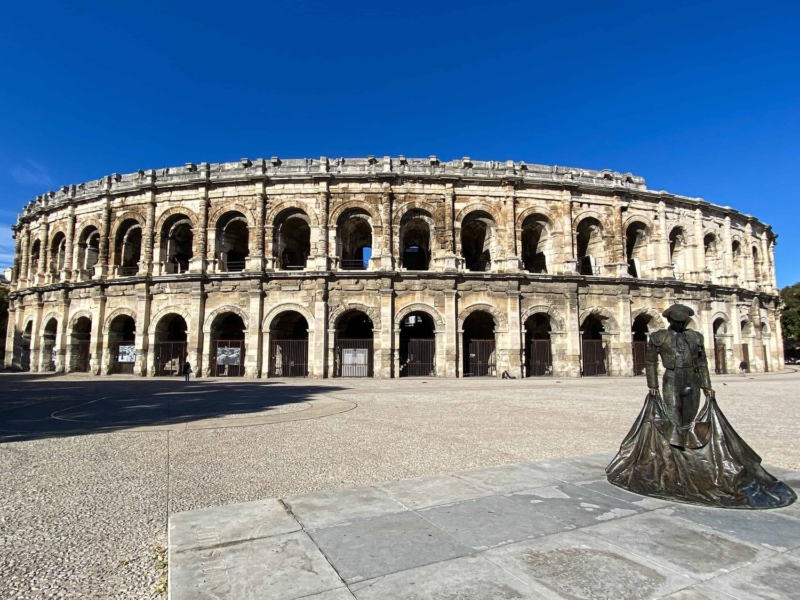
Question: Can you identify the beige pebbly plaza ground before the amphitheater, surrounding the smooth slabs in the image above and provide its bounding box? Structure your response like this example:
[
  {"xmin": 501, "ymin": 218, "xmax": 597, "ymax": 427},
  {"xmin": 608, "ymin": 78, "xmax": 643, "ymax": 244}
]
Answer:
[{"xmin": 0, "ymin": 371, "xmax": 800, "ymax": 599}]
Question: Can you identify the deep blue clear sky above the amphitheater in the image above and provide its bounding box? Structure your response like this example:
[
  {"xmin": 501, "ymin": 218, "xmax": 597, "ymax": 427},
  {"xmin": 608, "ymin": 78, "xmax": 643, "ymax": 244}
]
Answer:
[{"xmin": 0, "ymin": 0, "xmax": 800, "ymax": 286}]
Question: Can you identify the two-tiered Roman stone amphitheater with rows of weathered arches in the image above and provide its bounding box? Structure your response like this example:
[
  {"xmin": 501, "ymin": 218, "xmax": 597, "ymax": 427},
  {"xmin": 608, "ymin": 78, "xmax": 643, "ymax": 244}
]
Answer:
[{"xmin": 0, "ymin": 156, "xmax": 783, "ymax": 378}]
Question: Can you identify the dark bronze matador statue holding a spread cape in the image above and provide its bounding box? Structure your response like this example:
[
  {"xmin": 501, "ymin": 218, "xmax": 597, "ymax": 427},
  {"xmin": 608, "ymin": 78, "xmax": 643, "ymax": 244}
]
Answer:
[{"xmin": 606, "ymin": 304, "xmax": 797, "ymax": 508}]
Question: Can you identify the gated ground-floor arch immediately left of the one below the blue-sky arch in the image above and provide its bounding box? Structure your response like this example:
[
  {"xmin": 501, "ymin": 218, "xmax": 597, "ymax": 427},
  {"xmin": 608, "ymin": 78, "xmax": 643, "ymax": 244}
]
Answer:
[{"xmin": 269, "ymin": 310, "xmax": 308, "ymax": 377}]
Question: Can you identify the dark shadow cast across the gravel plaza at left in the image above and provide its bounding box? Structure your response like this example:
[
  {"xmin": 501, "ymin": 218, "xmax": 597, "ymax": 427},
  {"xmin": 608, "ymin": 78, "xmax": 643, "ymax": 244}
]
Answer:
[{"xmin": 0, "ymin": 373, "xmax": 347, "ymax": 442}]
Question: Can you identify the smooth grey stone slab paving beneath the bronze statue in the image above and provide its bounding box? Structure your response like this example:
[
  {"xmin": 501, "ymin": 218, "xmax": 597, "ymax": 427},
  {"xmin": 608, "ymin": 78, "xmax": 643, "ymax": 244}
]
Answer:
[{"xmin": 169, "ymin": 454, "xmax": 800, "ymax": 600}]
